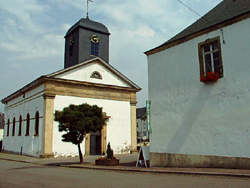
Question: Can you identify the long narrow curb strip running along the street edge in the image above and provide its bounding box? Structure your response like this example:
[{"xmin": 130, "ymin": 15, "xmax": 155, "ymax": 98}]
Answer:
[{"xmin": 0, "ymin": 158, "xmax": 250, "ymax": 178}]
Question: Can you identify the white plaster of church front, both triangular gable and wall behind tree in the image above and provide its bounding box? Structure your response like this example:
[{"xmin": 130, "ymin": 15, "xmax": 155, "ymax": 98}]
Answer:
[{"xmin": 53, "ymin": 61, "xmax": 131, "ymax": 155}]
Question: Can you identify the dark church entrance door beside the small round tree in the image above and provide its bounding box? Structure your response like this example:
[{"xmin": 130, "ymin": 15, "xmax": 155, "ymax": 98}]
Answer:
[{"xmin": 90, "ymin": 131, "xmax": 102, "ymax": 155}]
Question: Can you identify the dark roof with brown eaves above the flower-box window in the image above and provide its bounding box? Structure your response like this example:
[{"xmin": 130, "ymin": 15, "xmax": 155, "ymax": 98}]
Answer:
[{"xmin": 145, "ymin": 0, "xmax": 250, "ymax": 55}]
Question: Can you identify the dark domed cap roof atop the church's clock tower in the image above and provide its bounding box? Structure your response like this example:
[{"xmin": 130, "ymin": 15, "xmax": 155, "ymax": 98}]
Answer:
[{"xmin": 66, "ymin": 18, "xmax": 110, "ymax": 36}]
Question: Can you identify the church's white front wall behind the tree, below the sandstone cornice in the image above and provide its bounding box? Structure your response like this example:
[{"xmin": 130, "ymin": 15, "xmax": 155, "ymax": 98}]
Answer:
[{"xmin": 53, "ymin": 96, "xmax": 131, "ymax": 155}]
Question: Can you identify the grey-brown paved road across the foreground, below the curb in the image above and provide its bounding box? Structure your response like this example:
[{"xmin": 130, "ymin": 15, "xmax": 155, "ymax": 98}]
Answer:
[{"xmin": 0, "ymin": 160, "xmax": 250, "ymax": 188}]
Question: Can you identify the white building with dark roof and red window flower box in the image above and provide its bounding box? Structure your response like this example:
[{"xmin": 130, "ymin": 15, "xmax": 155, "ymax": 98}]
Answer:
[{"xmin": 145, "ymin": 0, "xmax": 250, "ymax": 168}]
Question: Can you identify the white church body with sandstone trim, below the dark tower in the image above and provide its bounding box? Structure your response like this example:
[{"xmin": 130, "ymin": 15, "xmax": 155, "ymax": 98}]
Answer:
[{"xmin": 3, "ymin": 58, "xmax": 140, "ymax": 157}]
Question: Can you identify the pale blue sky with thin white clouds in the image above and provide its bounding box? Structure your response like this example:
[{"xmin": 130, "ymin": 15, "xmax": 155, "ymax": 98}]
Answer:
[{"xmin": 0, "ymin": 0, "xmax": 222, "ymax": 112}]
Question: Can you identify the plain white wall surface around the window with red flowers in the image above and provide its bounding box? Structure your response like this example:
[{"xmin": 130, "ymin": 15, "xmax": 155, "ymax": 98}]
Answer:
[{"xmin": 148, "ymin": 19, "xmax": 250, "ymax": 157}]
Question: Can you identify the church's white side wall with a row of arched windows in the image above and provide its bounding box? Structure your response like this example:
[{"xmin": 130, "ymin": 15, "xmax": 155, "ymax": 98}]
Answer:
[{"xmin": 3, "ymin": 85, "xmax": 44, "ymax": 156}]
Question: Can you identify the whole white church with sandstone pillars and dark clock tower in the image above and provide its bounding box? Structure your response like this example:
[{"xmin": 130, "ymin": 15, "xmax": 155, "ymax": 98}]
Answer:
[{"xmin": 2, "ymin": 17, "xmax": 141, "ymax": 157}]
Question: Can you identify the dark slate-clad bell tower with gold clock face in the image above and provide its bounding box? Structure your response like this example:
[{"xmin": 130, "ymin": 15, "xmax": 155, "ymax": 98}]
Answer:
[{"xmin": 64, "ymin": 17, "xmax": 110, "ymax": 68}]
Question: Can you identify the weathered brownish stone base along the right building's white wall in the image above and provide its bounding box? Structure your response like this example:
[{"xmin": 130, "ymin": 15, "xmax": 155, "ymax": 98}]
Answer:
[{"xmin": 150, "ymin": 152, "xmax": 250, "ymax": 169}]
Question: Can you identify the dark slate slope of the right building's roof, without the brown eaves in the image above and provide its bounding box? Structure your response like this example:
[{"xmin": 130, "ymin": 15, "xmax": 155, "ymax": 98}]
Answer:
[{"xmin": 145, "ymin": 0, "xmax": 250, "ymax": 53}]
